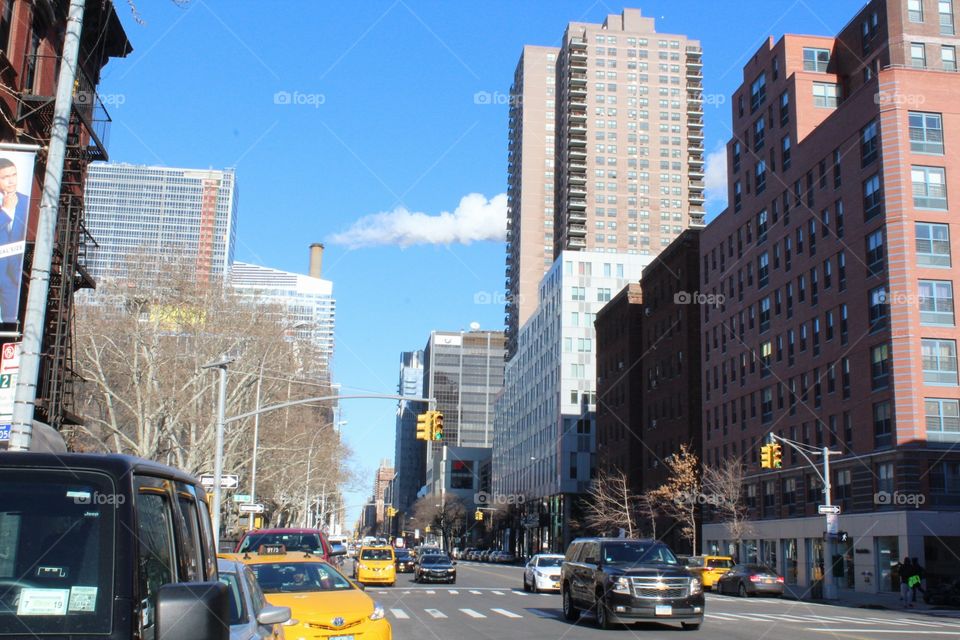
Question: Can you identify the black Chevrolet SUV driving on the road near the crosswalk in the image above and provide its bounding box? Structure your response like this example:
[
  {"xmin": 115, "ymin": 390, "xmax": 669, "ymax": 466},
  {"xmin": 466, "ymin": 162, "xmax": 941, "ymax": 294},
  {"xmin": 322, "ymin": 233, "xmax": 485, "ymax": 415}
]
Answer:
[{"xmin": 560, "ymin": 538, "xmax": 704, "ymax": 630}]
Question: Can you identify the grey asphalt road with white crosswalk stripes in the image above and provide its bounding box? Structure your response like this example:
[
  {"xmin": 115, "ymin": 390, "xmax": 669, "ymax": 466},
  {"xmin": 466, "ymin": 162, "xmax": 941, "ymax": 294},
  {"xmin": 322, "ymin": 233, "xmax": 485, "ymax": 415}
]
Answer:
[{"xmin": 347, "ymin": 562, "xmax": 960, "ymax": 640}]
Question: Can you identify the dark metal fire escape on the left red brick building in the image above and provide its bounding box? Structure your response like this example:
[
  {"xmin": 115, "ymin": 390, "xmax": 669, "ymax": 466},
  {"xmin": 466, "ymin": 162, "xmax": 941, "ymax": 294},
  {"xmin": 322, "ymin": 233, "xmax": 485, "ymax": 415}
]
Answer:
[{"xmin": 17, "ymin": 55, "xmax": 110, "ymax": 429}]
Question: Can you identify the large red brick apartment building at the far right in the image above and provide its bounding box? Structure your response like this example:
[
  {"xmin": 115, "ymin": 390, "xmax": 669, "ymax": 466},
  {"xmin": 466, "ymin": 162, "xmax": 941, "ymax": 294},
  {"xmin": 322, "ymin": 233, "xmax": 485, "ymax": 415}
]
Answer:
[{"xmin": 696, "ymin": 0, "xmax": 960, "ymax": 592}]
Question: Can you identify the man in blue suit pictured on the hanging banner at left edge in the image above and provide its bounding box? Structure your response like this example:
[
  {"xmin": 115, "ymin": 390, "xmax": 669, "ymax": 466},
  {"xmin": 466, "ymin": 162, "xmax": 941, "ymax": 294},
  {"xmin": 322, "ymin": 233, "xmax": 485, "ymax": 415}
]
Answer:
[{"xmin": 0, "ymin": 157, "xmax": 30, "ymax": 322}]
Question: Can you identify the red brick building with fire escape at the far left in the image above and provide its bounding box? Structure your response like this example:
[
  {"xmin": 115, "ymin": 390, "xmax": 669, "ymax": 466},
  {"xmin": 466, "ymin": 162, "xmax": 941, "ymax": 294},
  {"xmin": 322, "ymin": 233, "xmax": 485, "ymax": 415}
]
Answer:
[{"xmin": 0, "ymin": 0, "xmax": 132, "ymax": 436}]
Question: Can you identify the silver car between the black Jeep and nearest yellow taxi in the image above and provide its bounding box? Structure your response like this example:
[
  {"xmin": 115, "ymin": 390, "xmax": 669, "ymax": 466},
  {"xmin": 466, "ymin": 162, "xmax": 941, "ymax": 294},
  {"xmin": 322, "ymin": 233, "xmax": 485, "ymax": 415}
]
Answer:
[{"xmin": 217, "ymin": 558, "xmax": 290, "ymax": 640}]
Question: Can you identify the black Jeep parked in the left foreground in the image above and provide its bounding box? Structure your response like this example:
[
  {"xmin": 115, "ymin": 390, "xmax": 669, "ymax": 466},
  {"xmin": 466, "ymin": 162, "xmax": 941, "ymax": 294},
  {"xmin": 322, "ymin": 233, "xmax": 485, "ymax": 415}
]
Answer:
[{"xmin": 0, "ymin": 451, "xmax": 230, "ymax": 640}]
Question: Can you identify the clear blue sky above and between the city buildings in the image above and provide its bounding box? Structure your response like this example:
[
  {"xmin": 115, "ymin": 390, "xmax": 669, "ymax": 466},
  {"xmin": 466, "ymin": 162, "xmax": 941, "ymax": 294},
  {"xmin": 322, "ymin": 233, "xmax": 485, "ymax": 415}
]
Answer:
[{"xmin": 100, "ymin": 0, "xmax": 864, "ymax": 524}]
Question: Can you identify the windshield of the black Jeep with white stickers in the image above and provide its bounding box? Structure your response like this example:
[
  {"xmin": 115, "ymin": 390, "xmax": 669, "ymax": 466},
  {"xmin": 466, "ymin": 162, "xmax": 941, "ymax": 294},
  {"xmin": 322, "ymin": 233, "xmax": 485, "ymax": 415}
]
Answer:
[{"xmin": 0, "ymin": 469, "xmax": 115, "ymax": 638}]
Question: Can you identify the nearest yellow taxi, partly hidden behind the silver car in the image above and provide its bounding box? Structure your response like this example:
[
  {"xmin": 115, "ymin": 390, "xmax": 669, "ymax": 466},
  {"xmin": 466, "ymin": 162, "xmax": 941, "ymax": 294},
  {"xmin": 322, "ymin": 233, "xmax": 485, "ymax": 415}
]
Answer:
[{"xmin": 227, "ymin": 545, "xmax": 393, "ymax": 640}]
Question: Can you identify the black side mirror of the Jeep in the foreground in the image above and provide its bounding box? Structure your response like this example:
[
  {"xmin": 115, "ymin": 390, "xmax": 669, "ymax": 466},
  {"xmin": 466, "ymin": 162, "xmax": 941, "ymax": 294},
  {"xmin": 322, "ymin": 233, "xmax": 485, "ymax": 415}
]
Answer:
[{"xmin": 155, "ymin": 580, "xmax": 230, "ymax": 640}]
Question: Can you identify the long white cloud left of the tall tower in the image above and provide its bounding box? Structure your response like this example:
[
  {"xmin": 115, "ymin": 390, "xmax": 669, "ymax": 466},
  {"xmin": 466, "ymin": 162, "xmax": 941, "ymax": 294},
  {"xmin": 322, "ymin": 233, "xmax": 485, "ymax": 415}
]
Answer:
[{"xmin": 330, "ymin": 193, "xmax": 507, "ymax": 249}]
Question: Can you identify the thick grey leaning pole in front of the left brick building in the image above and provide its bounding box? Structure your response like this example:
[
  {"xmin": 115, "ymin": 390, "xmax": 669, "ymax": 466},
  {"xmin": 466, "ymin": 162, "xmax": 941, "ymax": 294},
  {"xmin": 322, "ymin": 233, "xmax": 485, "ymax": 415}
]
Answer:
[{"xmin": 9, "ymin": 0, "xmax": 86, "ymax": 451}]
